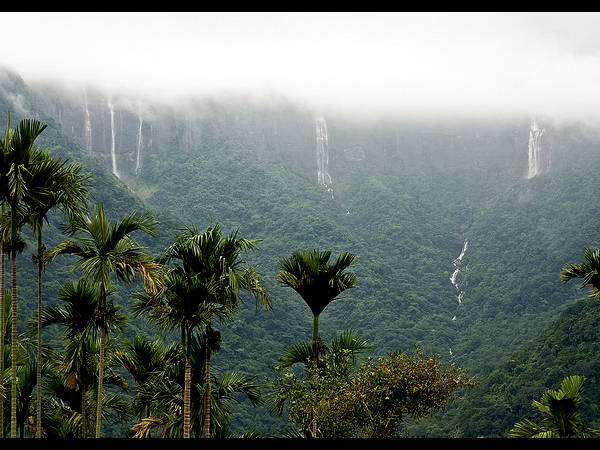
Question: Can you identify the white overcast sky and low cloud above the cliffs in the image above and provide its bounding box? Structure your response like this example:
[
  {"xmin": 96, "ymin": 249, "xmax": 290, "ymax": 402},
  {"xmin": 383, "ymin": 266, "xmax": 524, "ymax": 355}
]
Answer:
[{"xmin": 0, "ymin": 12, "xmax": 600, "ymax": 120}]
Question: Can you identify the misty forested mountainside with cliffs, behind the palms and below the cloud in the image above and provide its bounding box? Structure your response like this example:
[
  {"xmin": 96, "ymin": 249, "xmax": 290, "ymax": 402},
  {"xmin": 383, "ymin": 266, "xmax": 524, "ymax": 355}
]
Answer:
[{"xmin": 0, "ymin": 68, "xmax": 600, "ymax": 437}]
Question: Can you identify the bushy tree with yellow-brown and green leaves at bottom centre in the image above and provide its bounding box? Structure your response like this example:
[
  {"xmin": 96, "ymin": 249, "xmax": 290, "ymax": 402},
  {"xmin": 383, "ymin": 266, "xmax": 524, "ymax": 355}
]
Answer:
[{"xmin": 273, "ymin": 335, "xmax": 473, "ymax": 438}]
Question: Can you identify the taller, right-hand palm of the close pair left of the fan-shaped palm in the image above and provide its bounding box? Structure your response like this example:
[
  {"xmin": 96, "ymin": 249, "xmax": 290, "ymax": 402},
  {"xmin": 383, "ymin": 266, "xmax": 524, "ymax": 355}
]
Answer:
[{"xmin": 161, "ymin": 223, "xmax": 270, "ymax": 437}]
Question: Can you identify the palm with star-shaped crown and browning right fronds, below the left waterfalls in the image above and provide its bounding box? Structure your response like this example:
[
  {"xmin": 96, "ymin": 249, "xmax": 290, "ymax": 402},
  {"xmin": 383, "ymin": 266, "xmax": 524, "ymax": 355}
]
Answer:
[{"xmin": 50, "ymin": 203, "xmax": 158, "ymax": 437}]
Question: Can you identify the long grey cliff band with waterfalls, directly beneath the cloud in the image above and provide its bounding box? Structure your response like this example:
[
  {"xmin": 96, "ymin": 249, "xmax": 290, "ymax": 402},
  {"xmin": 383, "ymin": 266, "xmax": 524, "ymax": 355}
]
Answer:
[{"xmin": 0, "ymin": 69, "xmax": 566, "ymax": 194}]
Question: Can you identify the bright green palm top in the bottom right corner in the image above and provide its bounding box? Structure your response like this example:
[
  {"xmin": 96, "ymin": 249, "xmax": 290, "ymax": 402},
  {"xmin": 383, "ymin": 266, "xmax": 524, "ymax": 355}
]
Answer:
[{"xmin": 508, "ymin": 375, "xmax": 600, "ymax": 438}]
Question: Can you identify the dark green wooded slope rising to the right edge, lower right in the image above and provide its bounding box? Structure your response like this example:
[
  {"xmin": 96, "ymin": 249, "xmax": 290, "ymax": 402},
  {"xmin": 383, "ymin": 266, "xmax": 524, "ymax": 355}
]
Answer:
[{"xmin": 434, "ymin": 299, "xmax": 600, "ymax": 438}]
